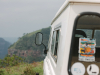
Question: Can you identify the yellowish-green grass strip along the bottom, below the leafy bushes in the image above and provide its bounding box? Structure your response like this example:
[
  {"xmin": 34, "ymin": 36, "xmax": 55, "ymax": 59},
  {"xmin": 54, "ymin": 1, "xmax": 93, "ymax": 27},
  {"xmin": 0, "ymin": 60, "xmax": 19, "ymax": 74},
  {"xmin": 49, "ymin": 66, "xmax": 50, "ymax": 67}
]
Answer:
[{"xmin": 0, "ymin": 61, "xmax": 43, "ymax": 75}]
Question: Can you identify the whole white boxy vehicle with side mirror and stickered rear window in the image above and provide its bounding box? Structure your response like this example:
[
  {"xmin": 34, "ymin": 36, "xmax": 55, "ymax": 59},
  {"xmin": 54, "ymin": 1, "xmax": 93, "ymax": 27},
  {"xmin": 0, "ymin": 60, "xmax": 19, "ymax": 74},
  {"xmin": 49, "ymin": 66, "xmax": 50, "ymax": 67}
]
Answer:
[{"xmin": 36, "ymin": 0, "xmax": 100, "ymax": 75}]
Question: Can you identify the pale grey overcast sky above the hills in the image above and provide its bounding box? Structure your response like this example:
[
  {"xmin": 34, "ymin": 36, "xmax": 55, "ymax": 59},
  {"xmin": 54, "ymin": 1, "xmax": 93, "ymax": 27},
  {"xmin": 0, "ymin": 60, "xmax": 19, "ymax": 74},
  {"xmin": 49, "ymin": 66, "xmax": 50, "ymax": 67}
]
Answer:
[{"xmin": 0, "ymin": 0, "xmax": 65, "ymax": 37}]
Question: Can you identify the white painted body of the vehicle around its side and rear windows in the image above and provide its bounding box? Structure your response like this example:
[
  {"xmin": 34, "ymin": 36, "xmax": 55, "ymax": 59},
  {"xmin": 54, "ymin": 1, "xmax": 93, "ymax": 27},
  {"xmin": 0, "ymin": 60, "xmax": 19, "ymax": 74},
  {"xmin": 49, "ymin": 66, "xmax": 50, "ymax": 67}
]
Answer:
[{"xmin": 44, "ymin": 0, "xmax": 100, "ymax": 75}]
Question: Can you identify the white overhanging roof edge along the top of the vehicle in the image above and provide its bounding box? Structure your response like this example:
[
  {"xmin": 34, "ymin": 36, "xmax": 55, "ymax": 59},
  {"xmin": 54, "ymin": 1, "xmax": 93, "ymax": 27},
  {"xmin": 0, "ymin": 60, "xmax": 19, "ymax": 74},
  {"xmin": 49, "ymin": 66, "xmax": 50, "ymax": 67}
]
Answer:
[{"xmin": 51, "ymin": 0, "xmax": 100, "ymax": 25}]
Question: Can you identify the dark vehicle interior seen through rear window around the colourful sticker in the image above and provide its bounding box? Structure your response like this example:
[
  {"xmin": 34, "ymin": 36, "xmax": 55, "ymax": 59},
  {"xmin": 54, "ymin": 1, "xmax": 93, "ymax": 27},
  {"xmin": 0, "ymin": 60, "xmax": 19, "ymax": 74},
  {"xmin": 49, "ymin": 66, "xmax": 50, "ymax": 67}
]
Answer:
[{"xmin": 71, "ymin": 15, "xmax": 100, "ymax": 75}]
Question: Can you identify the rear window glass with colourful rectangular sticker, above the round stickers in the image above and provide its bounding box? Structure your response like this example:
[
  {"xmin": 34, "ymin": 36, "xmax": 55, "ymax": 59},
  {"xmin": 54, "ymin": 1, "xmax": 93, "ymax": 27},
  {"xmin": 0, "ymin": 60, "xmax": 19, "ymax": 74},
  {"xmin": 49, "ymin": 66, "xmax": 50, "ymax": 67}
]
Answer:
[{"xmin": 69, "ymin": 15, "xmax": 100, "ymax": 75}]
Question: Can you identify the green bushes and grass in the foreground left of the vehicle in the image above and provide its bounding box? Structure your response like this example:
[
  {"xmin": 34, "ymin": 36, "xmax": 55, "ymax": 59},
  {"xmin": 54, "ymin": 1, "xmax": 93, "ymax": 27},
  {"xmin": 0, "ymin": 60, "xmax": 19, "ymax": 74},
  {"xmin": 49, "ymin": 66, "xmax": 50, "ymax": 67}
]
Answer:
[{"xmin": 0, "ymin": 55, "xmax": 43, "ymax": 75}]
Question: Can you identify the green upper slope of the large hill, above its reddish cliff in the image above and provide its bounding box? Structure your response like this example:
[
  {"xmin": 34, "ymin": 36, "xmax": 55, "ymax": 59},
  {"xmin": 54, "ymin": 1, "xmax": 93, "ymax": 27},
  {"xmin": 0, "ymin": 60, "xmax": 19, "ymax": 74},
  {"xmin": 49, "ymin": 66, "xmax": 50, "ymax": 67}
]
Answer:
[{"xmin": 9, "ymin": 27, "xmax": 50, "ymax": 50}]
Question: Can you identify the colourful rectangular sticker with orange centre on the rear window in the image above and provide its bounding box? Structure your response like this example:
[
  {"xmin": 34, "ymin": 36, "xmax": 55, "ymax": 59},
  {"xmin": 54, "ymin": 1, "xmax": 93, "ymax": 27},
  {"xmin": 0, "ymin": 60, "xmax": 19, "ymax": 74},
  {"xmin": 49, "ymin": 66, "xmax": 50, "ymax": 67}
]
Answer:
[{"xmin": 79, "ymin": 38, "xmax": 96, "ymax": 62}]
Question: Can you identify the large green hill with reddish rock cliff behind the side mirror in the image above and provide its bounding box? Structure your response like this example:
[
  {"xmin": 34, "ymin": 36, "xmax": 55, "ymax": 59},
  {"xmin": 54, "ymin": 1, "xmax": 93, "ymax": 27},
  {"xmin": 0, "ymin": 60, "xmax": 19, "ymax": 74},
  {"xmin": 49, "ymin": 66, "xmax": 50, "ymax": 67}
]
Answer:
[{"xmin": 8, "ymin": 27, "xmax": 50, "ymax": 62}]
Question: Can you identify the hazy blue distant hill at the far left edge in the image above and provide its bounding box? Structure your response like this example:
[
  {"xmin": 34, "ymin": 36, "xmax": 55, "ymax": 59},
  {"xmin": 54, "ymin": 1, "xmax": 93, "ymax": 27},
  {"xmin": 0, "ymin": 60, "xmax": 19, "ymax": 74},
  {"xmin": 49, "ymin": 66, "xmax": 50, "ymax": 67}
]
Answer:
[{"xmin": 0, "ymin": 38, "xmax": 11, "ymax": 59}]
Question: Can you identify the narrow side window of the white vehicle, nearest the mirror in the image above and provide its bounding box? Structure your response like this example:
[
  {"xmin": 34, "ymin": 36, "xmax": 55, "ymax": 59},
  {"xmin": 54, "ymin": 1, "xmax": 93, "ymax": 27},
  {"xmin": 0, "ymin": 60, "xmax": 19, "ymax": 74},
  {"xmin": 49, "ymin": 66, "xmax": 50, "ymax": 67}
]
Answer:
[{"xmin": 51, "ymin": 30, "xmax": 59, "ymax": 61}]
